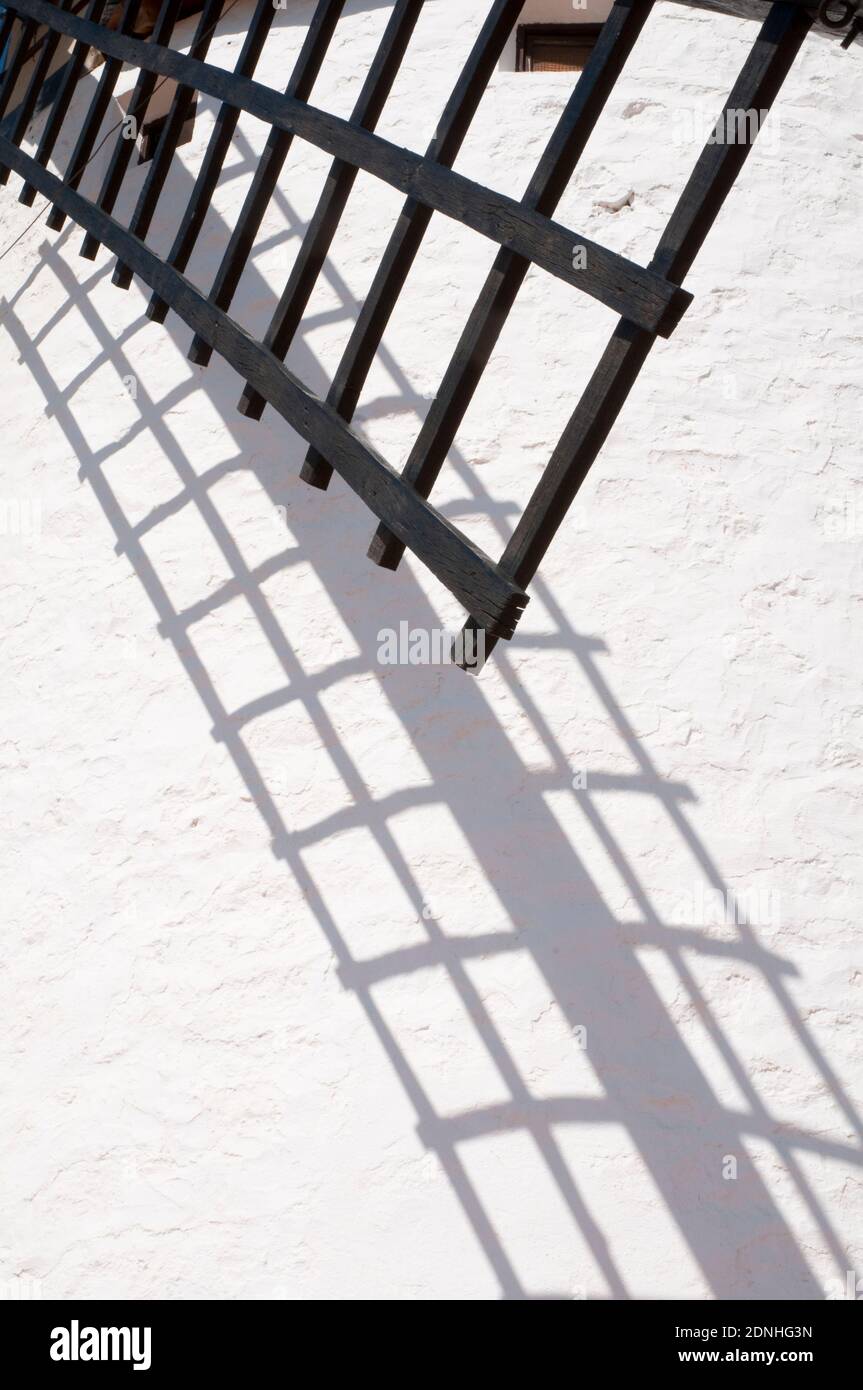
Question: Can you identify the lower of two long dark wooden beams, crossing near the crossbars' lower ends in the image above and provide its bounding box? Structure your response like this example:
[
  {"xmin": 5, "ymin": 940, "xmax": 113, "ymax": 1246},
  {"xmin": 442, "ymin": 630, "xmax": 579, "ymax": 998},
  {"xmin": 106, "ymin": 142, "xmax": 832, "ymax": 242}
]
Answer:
[{"xmin": 0, "ymin": 125, "xmax": 527, "ymax": 637}]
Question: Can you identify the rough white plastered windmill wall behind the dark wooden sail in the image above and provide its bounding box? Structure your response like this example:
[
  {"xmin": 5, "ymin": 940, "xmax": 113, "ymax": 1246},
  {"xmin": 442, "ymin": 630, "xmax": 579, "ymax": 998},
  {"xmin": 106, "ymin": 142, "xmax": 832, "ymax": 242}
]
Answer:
[{"xmin": 0, "ymin": 0, "xmax": 863, "ymax": 1300}]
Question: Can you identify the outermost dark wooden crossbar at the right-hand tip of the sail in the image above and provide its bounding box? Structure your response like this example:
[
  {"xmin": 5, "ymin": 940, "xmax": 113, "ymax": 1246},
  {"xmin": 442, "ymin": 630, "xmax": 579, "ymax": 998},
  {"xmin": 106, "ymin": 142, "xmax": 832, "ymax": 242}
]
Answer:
[{"xmin": 453, "ymin": 3, "xmax": 813, "ymax": 667}]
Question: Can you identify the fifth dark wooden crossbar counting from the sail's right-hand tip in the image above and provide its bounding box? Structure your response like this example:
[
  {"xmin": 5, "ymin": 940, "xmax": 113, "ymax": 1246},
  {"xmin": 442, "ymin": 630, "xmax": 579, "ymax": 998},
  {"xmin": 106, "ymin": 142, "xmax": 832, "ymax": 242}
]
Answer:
[{"xmin": 188, "ymin": 0, "xmax": 345, "ymax": 367}]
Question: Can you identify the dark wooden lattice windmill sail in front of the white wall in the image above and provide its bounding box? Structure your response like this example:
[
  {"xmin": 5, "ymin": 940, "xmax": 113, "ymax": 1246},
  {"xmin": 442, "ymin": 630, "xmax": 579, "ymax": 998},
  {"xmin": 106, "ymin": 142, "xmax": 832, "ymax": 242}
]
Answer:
[{"xmin": 0, "ymin": 0, "xmax": 853, "ymax": 667}]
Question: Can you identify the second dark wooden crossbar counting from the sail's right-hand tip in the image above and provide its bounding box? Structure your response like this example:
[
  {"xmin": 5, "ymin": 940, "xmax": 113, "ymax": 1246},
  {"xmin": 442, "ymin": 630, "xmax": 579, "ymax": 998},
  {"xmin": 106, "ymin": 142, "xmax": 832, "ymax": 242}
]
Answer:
[{"xmin": 368, "ymin": 0, "xmax": 653, "ymax": 570}]
